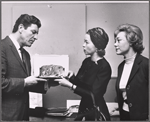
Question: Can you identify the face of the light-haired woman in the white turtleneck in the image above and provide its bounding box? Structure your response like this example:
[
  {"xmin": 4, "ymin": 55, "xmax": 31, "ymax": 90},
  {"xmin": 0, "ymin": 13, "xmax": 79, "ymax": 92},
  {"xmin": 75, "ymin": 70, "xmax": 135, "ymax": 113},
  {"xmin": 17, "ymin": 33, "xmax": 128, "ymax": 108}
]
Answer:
[{"xmin": 114, "ymin": 32, "xmax": 130, "ymax": 55}]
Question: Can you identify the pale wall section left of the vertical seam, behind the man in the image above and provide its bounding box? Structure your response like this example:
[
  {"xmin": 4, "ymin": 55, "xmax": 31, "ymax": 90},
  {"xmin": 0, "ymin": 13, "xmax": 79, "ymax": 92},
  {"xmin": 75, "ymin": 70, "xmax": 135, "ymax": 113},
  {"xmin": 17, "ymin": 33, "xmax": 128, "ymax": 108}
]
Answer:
[{"xmin": 2, "ymin": 3, "xmax": 85, "ymax": 72}]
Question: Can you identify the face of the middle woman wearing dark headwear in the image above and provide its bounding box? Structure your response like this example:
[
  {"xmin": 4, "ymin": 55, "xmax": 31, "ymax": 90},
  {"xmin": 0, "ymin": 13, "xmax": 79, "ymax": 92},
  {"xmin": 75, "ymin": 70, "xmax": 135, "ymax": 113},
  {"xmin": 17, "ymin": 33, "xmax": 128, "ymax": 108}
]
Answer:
[{"xmin": 83, "ymin": 34, "xmax": 97, "ymax": 55}]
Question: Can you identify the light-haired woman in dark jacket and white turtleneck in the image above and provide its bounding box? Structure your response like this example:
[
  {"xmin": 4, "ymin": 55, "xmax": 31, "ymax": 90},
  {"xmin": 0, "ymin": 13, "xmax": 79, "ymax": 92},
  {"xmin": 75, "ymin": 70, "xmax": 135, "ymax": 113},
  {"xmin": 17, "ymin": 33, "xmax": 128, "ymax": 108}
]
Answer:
[{"xmin": 114, "ymin": 24, "xmax": 149, "ymax": 120}]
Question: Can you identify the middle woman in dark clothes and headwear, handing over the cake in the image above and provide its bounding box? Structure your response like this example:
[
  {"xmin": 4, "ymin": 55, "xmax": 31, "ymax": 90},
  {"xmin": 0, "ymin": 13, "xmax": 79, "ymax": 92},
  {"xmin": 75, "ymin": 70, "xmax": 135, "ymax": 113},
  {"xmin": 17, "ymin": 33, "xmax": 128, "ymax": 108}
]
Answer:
[{"xmin": 55, "ymin": 27, "xmax": 111, "ymax": 121}]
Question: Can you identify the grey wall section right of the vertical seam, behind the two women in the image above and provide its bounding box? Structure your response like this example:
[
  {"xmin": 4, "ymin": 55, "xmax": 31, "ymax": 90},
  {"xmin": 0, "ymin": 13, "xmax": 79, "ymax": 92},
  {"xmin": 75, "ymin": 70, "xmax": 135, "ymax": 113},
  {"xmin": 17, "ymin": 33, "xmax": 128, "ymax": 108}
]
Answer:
[{"xmin": 86, "ymin": 3, "xmax": 149, "ymax": 77}]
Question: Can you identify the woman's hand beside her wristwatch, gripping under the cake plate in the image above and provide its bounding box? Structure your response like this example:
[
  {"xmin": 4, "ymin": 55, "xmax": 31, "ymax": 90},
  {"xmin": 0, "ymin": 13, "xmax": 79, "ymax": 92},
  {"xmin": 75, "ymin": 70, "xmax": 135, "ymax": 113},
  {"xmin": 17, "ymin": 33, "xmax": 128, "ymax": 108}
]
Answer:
[{"xmin": 54, "ymin": 78, "xmax": 73, "ymax": 88}]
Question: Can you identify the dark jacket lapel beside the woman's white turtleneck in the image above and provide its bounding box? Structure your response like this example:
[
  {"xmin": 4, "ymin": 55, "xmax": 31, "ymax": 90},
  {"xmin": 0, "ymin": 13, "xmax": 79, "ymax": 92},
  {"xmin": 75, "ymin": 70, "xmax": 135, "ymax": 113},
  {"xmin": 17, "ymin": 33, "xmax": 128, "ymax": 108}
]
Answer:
[{"xmin": 127, "ymin": 54, "xmax": 142, "ymax": 84}]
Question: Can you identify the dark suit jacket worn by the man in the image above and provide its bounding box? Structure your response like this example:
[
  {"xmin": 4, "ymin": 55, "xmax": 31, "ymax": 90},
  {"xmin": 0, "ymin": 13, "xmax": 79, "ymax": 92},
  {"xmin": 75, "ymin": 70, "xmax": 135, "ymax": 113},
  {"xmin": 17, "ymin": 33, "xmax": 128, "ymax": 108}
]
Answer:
[{"xmin": 1, "ymin": 36, "xmax": 46, "ymax": 121}]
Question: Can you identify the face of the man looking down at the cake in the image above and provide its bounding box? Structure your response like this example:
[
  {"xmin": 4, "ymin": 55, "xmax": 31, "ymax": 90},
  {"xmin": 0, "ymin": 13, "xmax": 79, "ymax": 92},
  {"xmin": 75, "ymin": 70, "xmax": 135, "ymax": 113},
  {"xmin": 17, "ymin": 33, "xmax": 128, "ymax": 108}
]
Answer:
[{"xmin": 19, "ymin": 24, "xmax": 39, "ymax": 47}]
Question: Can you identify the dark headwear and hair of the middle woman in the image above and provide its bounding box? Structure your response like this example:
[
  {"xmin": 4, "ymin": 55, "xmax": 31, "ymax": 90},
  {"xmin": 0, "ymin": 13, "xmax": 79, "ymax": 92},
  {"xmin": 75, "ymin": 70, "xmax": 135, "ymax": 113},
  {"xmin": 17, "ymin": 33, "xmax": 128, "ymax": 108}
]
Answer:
[{"xmin": 86, "ymin": 27, "xmax": 109, "ymax": 57}]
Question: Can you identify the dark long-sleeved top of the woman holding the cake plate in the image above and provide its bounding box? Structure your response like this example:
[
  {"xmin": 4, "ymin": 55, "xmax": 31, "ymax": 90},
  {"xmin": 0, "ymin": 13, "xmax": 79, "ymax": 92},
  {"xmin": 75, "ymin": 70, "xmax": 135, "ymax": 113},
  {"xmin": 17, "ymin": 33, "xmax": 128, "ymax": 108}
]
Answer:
[{"xmin": 70, "ymin": 57, "xmax": 111, "ymax": 120}]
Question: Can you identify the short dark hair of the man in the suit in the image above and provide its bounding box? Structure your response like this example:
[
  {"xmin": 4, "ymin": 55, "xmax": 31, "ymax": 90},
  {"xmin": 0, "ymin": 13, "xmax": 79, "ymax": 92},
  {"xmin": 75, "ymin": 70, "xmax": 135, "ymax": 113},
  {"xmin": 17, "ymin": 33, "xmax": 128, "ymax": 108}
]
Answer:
[{"xmin": 12, "ymin": 14, "xmax": 41, "ymax": 33}]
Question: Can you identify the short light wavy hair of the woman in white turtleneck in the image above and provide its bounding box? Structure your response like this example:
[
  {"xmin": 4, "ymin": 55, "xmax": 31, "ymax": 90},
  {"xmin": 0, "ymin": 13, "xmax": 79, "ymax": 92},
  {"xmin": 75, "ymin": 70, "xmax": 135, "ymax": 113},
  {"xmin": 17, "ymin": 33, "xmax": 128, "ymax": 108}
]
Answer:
[{"xmin": 114, "ymin": 24, "xmax": 144, "ymax": 54}]
